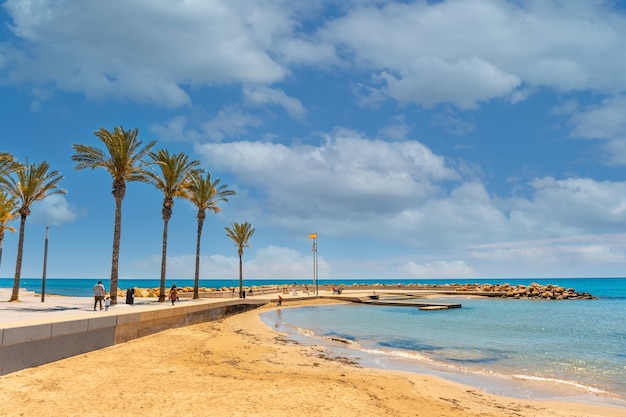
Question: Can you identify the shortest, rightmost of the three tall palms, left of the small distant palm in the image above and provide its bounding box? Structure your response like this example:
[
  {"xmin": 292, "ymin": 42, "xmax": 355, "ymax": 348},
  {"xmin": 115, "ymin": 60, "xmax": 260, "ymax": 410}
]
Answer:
[{"xmin": 186, "ymin": 172, "xmax": 236, "ymax": 299}]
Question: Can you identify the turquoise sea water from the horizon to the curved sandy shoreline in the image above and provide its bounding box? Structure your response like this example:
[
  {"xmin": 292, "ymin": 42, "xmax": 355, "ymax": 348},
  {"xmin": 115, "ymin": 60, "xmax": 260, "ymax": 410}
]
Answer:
[{"xmin": 0, "ymin": 278, "xmax": 626, "ymax": 409}]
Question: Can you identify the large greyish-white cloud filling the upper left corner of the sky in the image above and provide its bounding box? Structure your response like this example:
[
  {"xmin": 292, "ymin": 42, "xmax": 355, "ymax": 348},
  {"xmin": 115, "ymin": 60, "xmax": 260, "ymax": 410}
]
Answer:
[{"xmin": 4, "ymin": 0, "xmax": 292, "ymax": 107}]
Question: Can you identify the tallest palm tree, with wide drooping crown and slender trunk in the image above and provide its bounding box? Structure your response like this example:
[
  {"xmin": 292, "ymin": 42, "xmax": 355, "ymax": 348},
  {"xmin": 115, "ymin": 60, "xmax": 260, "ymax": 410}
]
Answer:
[{"xmin": 72, "ymin": 126, "xmax": 156, "ymax": 304}]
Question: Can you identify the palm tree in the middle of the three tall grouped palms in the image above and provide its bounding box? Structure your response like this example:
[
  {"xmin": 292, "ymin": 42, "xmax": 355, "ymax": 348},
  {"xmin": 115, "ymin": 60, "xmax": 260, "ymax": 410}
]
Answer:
[{"xmin": 147, "ymin": 149, "xmax": 200, "ymax": 302}]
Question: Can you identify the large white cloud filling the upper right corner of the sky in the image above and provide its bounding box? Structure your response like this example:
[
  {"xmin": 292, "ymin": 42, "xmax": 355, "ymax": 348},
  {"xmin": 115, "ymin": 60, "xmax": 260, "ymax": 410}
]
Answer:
[{"xmin": 319, "ymin": 0, "xmax": 626, "ymax": 108}]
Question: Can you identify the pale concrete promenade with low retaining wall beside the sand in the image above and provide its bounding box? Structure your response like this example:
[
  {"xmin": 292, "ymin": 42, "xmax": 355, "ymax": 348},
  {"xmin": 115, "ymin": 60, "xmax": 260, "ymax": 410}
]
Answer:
[{"xmin": 0, "ymin": 288, "xmax": 291, "ymax": 375}]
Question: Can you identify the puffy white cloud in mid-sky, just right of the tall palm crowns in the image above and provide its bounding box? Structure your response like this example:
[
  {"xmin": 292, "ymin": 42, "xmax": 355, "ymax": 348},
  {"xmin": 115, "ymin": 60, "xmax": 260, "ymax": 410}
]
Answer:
[{"xmin": 196, "ymin": 129, "xmax": 457, "ymax": 224}]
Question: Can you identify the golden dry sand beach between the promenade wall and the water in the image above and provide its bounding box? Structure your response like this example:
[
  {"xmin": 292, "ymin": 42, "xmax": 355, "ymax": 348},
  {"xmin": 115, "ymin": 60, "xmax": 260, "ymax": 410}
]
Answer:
[{"xmin": 0, "ymin": 301, "xmax": 626, "ymax": 417}]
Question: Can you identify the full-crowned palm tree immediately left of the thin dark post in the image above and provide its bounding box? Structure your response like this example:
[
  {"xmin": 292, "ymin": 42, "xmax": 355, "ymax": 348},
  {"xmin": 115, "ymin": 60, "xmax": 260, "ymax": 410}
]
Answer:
[{"xmin": 6, "ymin": 159, "xmax": 65, "ymax": 301}]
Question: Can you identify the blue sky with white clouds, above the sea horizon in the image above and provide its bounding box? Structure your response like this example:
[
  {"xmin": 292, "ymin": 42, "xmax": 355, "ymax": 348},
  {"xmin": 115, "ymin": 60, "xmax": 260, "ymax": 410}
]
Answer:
[{"xmin": 0, "ymin": 0, "xmax": 626, "ymax": 280}]
